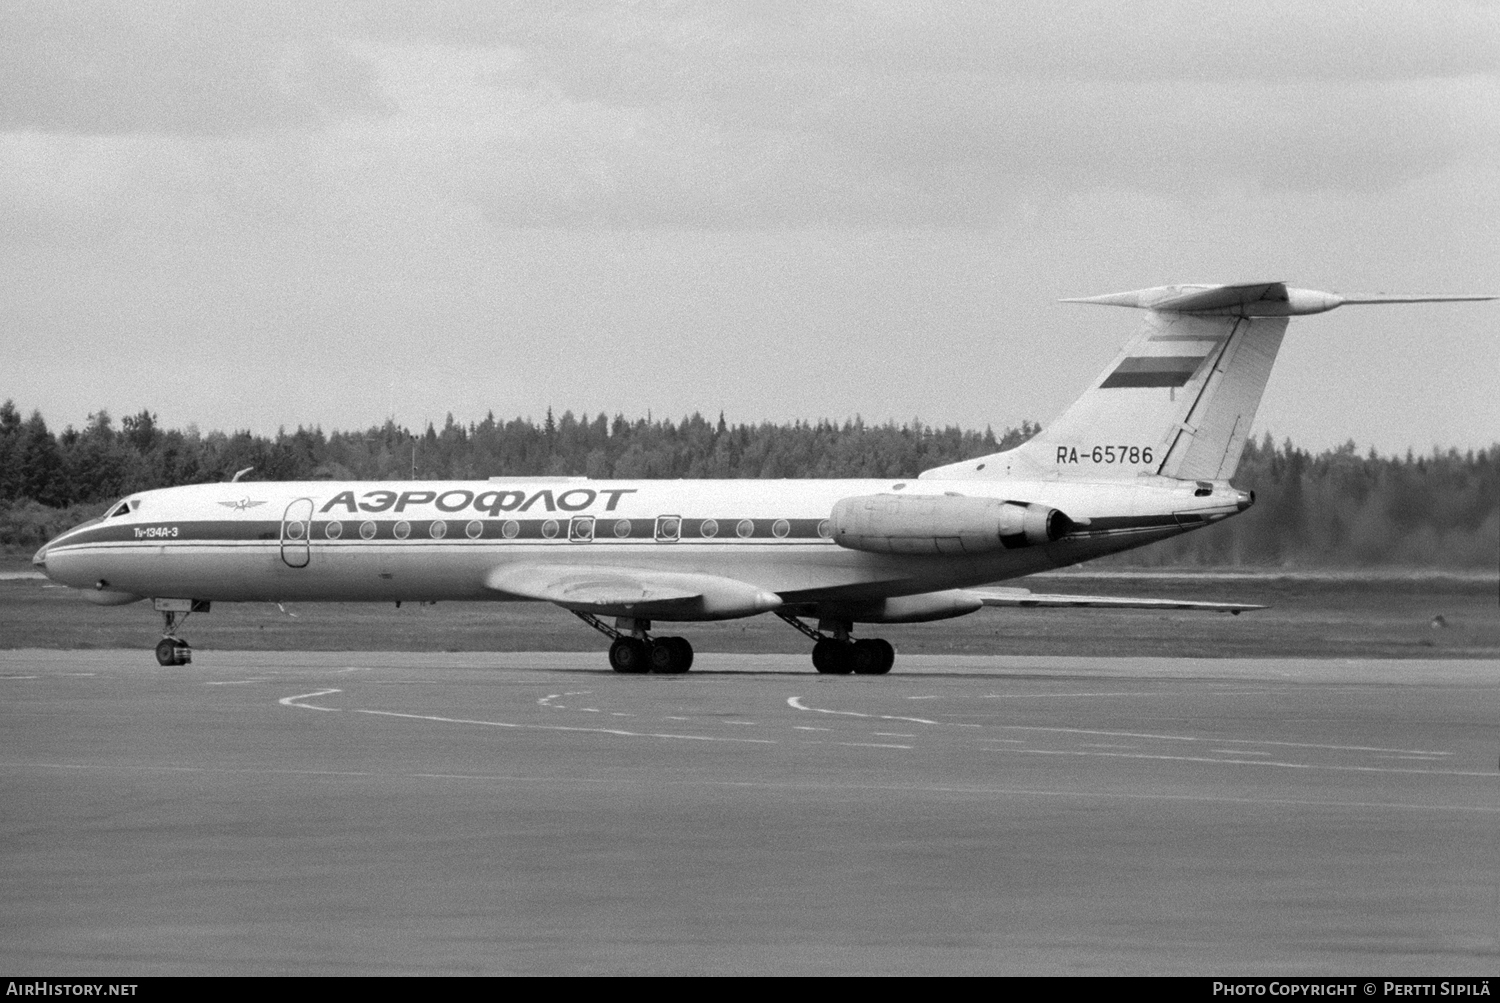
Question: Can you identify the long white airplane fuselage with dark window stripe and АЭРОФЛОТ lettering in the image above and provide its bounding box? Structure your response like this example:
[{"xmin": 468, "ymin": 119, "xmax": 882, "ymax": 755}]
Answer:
[{"xmin": 36, "ymin": 477, "xmax": 1250, "ymax": 618}]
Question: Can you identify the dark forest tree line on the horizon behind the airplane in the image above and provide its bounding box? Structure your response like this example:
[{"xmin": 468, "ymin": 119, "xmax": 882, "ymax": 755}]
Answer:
[{"xmin": 0, "ymin": 400, "xmax": 1500, "ymax": 568}]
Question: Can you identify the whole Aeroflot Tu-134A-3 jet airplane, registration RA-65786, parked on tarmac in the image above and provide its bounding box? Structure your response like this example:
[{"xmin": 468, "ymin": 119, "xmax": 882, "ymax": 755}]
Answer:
[{"xmin": 33, "ymin": 282, "xmax": 1496, "ymax": 675}]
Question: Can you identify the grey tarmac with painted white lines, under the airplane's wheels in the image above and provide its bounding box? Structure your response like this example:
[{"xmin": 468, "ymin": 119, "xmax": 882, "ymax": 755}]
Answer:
[{"xmin": 0, "ymin": 651, "xmax": 1500, "ymax": 978}]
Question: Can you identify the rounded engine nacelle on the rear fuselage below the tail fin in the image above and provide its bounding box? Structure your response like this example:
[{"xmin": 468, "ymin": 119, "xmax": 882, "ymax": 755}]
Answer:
[{"xmin": 830, "ymin": 495, "xmax": 1074, "ymax": 555}]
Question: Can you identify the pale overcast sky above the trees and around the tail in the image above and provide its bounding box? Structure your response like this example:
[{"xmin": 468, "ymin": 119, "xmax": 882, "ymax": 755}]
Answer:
[{"xmin": 0, "ymin": 0, "xmax": 1500, "ymax": 451}]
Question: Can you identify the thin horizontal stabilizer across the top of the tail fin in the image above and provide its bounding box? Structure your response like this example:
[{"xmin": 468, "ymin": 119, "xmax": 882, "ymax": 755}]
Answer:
[{"xmin": 1064, "ymin": 282, "xmax": 1496, "ymax": 316}]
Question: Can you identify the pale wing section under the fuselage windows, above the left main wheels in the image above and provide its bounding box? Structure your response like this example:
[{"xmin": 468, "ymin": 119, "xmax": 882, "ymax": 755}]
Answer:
[{"xmin": 485, "ymin": 564, "xmax": 782, "ymax": 619}]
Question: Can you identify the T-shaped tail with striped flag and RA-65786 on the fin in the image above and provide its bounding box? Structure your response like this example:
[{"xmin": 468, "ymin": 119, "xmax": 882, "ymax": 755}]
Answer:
[{"xmin": 923, "ymin": 282, "xmax": 1496, "ymax": 480}]
